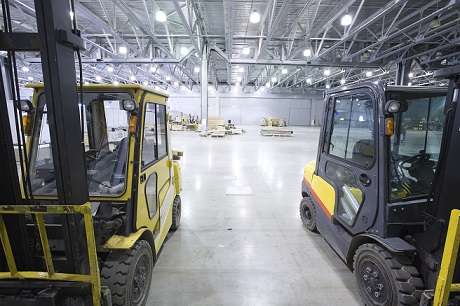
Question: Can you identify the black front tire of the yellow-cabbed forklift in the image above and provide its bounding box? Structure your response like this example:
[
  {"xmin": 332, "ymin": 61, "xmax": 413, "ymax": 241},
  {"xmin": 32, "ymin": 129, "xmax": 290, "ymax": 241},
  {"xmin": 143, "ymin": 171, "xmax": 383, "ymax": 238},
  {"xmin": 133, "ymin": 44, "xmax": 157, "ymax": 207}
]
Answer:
[{"xmin": 101, "ymin": 240, "xmax": 153, "ymax": 306}]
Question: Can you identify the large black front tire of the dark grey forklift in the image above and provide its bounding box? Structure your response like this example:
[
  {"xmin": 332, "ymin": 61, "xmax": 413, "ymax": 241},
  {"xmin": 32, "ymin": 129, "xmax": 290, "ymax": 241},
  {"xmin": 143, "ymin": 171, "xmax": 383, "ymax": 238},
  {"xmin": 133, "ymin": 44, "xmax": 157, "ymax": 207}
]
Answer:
[{"xmin": 353, "ymin": 243, "xmax": 424, "ymax": 306}]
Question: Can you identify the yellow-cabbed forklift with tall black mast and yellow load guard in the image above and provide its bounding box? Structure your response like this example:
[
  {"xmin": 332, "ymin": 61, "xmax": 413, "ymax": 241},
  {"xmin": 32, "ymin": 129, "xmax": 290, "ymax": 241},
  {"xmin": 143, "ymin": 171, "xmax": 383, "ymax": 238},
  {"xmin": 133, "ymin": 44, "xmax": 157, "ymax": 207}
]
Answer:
[{"xmin": 0, "ymin": 0, "xmax": 182, "ymax": 306}]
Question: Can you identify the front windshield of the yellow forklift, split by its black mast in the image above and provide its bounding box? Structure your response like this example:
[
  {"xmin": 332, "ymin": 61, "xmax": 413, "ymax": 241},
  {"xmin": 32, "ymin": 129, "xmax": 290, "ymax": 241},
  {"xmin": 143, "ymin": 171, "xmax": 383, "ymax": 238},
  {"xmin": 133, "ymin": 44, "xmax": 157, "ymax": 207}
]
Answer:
[{"xmin": 30, "ymin": 92, "xmax": 132, "ymax": 196}]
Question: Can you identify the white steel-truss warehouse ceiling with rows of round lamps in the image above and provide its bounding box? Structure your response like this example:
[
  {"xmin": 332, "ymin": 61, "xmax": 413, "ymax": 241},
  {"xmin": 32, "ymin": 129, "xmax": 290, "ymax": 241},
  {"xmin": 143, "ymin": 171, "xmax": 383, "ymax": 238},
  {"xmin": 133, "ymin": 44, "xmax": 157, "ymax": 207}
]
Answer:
[{"xmin": 4, "ymin": 0, "xmax": 460, "ymax": 92}]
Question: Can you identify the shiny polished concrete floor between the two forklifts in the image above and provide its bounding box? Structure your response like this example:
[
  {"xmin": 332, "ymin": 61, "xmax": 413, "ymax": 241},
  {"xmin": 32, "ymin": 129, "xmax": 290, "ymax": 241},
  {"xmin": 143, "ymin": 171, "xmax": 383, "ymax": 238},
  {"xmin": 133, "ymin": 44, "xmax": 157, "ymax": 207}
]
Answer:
[{"xmin": 147, "ymin": 127, "xmax": 362, "ymax": 306}]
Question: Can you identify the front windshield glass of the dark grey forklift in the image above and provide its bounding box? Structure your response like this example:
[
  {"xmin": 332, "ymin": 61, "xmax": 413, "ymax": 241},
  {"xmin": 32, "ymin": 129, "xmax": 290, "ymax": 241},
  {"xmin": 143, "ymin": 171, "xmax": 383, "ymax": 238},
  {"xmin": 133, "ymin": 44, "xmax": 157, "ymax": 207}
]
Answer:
[{"xmin": 390, "ymin": 93, "xmax": 446, "ymax": 201}]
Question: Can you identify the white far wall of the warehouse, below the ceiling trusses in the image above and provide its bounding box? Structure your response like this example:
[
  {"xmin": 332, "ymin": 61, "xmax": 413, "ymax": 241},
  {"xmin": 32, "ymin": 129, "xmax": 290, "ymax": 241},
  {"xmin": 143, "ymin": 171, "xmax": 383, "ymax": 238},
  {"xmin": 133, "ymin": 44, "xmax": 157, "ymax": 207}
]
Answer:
[{"xmin": 168, "ymin": 87, "xmax": 324, "ymax": 125}]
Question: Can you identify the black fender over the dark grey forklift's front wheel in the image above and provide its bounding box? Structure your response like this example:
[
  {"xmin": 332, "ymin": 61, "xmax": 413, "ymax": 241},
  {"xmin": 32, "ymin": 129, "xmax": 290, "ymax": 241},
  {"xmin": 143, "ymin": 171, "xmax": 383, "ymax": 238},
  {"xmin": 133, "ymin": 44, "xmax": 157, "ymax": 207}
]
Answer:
[{"xmin": 347, "ymin": 234, "xmax": 417, "ymax": 269}]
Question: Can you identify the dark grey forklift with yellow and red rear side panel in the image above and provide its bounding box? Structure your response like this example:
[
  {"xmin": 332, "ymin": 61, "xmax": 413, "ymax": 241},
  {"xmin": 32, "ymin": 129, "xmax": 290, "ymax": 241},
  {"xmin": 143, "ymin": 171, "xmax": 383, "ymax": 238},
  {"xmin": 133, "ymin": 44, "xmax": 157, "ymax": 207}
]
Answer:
[{"xmin": 300, "ymin": 67, "xmax": 460, "ymax": 306}]
